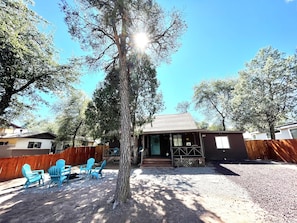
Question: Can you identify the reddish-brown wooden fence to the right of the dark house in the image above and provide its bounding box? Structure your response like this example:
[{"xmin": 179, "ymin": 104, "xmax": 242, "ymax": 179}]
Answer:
[{"xmin": 245, "ymin": 139, "xmax": 297, "ymax": 163}]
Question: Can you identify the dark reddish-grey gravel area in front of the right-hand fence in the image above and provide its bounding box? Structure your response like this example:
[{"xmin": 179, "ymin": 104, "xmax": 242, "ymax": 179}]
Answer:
[{"xmin": 215, "ymin": 163, "xmax": 297, "ymax": 223}]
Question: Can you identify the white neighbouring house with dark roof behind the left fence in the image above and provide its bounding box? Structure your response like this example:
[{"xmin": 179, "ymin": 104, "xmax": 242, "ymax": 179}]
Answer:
[{"xmin": 0, "ymin": 132, "xmax": 56, "ymax": 157}]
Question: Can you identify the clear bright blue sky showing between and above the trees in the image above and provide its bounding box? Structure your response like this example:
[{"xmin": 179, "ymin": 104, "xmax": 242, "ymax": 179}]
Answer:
[{"xmin": 33, "ymin": 0, "xmax": 297, "ymax": 121}]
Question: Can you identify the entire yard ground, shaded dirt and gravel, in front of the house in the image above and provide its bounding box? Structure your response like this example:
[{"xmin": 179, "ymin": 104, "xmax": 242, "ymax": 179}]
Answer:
[{"xmin": 0, "ymin": 163, "xmax": 297, "ymax": 223}]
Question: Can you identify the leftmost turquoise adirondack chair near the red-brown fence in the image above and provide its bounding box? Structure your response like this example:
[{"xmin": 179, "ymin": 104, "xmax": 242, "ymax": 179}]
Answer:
[{"xmin": 22, "ymin": 163, "xmax": 44, "ymax": 188}]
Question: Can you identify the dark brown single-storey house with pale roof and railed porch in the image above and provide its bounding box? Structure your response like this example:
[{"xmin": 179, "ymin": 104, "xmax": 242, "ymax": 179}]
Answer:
[{"xmin": 139, "ymin": 113, "xmax": 248, "ymax": 166}]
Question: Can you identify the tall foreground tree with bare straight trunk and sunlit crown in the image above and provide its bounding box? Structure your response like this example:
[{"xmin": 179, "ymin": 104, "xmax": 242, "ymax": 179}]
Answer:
[{"xmin": 61, "ymin": 0, "xmax": 185, "ymax": 204}]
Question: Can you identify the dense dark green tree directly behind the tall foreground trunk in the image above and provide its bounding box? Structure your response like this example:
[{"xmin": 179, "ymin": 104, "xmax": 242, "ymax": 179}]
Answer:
[{"xmin": 86, "ymin": 56, "xmax": 163, "ymax": 141}]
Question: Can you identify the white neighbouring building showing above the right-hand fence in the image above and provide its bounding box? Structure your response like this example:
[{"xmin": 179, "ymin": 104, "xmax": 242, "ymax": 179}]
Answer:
[{"xmin": 248, "ymin": 123, "xmax": 297, "ymax": 140}]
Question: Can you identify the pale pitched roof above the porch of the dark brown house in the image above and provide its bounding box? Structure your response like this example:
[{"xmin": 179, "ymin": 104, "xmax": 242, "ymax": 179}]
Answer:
[{"xmin": 142, "ymin": 113, "xmax": 198, "ymax": 134}]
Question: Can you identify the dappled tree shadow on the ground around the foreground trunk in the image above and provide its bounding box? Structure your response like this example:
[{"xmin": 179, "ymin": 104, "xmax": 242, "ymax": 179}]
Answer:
[{"xmin": 0, "ymin": 171, "xmax": 223, "ymax": 223}]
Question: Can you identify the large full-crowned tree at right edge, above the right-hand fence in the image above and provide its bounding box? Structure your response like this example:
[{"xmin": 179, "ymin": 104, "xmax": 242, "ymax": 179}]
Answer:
[{"xmin": 233, "ymin": 47, "xmax": 297, "ymax": 139}]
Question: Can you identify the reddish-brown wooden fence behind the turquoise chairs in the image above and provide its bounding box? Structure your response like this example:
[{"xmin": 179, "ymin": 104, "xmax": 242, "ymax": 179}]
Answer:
[{"xmin": 0, "ymin": 146, "xmax": 106, "ymax": 181}]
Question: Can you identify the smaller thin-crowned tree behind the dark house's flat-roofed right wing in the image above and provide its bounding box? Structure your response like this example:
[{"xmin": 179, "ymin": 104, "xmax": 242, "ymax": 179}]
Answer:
[{"xmin": 194, "ymin": 80, "xmax": 235, "ymax": 130}]
